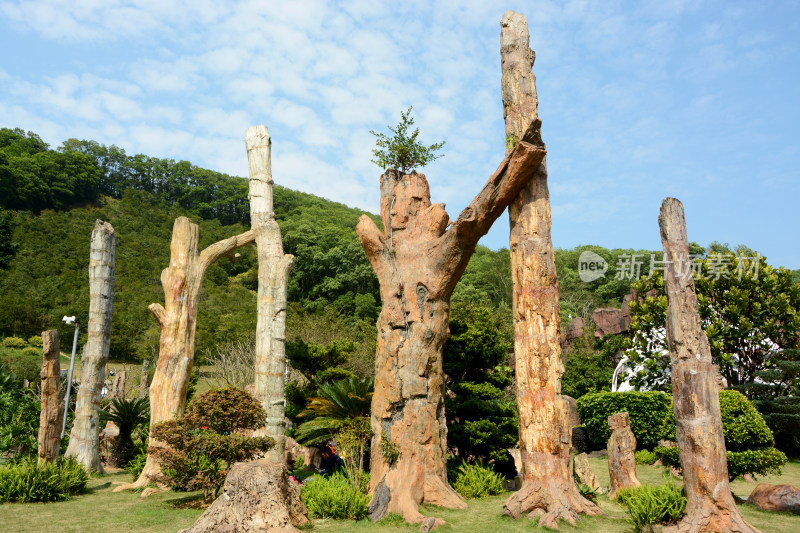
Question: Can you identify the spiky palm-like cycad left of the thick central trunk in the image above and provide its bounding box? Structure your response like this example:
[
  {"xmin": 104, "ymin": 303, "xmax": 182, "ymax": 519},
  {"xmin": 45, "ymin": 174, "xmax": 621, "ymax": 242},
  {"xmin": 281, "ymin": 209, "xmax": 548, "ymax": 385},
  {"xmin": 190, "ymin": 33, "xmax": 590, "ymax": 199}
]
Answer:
[{"xmin": 297, "ymin": 378, "xmax": 374, "ymax": 446}]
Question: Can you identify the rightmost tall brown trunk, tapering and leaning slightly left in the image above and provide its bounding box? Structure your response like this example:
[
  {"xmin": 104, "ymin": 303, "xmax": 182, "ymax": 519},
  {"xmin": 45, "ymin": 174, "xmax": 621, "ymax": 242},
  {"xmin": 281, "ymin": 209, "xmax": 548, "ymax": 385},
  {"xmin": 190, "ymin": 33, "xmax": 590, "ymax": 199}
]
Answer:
[{"xmin": 658, "ymin": 198, "xmax": 757, "ymax": 533}]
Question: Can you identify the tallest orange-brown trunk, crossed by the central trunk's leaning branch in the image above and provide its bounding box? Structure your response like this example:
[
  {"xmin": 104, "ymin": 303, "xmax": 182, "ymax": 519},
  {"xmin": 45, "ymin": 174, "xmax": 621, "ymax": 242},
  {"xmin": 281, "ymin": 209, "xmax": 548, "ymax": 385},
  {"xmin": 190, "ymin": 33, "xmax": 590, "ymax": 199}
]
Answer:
[{"xmin": 500, "ymin": 11, "xmax": 600, "ymax": 528}]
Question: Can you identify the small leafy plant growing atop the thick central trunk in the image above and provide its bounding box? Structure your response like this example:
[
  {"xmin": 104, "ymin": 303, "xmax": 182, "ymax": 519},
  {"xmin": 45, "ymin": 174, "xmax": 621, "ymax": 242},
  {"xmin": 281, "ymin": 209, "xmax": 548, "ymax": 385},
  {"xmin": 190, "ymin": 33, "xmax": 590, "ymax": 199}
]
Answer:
[{"xmin": 370, "ymin": 106, "xmax": 445, "ymax": 174}]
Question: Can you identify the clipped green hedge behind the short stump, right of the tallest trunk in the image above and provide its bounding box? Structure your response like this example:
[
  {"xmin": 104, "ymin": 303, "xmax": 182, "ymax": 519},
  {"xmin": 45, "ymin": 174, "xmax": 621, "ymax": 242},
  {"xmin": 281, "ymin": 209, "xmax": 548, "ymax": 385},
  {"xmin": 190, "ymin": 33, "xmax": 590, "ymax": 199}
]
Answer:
[{"xmin": 577, "ymin": 391, "xmax": 672, "ymax": 449}]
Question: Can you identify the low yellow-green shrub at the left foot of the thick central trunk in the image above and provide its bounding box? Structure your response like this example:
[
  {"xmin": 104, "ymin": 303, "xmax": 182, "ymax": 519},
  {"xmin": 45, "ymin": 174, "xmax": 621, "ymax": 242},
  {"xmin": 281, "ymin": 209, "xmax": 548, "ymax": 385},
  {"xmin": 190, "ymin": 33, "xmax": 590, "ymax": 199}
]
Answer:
[{"xmin": 300, "ymin": 472, "xmax": 369, "ymax": 520}]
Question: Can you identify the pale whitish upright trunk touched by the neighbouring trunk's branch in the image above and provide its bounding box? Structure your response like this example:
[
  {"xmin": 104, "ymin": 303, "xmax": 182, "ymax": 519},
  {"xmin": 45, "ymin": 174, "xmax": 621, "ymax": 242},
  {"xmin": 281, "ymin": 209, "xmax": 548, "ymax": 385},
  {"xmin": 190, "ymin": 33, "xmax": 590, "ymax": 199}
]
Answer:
[{"xmin": 245, "ymin": 126, "xmax": 294, "ymax": 463}]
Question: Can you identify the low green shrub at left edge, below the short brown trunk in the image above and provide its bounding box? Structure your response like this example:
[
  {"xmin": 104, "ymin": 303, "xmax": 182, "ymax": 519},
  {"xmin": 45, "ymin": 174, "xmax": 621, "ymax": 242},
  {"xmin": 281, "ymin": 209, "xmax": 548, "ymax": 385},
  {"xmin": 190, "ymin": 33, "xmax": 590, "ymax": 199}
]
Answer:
[{"xmin": 0, "ymin": 457, "xmax": 89, "ymax": 503}]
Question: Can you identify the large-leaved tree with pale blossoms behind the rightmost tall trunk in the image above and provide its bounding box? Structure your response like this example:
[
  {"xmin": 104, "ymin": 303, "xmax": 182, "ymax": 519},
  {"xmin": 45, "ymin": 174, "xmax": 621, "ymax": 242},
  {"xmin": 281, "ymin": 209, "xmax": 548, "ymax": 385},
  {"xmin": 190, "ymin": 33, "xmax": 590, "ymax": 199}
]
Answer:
[{"xmin": 628, "ymin": 245, "xmax": 800, "ymax": 390}]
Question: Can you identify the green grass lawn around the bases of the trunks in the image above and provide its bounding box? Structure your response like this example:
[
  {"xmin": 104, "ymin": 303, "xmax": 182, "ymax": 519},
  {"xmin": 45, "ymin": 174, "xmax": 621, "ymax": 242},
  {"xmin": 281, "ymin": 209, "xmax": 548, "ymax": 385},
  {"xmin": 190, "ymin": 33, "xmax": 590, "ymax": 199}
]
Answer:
[{"xmin": 0, "ymin": 458, "xmax": 800, "ymax": 533}]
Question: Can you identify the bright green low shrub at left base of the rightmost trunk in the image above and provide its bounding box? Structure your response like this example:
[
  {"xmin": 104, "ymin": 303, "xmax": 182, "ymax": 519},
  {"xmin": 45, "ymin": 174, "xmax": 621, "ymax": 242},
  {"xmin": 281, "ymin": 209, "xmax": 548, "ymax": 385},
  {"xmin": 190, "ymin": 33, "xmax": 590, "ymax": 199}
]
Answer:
[{"xmin": 617, "ymin": 480, "xmax": 686, "ymax": 532}]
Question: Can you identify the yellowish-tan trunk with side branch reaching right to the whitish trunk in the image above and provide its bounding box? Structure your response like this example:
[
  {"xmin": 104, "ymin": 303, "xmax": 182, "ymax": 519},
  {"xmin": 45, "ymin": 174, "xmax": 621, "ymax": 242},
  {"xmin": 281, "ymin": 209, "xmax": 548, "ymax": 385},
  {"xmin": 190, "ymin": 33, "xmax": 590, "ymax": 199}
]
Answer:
[{"xmin": 114, "ymin": 217, "xmax": 255, "ymax": 492}]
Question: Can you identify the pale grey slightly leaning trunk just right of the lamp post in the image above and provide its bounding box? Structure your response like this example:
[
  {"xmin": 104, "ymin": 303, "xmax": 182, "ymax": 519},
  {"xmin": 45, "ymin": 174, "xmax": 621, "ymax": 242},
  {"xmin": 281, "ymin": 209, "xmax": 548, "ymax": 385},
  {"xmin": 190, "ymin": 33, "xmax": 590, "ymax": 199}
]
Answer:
[{"xmin": 65, "ymin": 220, "xmax": 116, "ymax": 472}]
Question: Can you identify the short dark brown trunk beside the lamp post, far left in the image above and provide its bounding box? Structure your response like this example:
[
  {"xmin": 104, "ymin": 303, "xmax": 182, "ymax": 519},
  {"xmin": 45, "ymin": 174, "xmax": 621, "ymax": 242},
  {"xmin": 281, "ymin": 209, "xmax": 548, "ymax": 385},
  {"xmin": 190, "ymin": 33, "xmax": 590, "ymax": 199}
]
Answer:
[{"xmin": 39, "ymin": 329, "xmax": 64, "ymax": 464}]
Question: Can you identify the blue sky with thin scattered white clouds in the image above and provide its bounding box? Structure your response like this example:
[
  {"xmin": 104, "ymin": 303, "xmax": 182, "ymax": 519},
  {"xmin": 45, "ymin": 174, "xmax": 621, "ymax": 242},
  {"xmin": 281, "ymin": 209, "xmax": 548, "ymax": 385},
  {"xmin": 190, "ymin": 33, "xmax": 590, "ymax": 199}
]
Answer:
[{"xmin": 0, "ymin": 0, "xmax": 800, "ymax": 269}]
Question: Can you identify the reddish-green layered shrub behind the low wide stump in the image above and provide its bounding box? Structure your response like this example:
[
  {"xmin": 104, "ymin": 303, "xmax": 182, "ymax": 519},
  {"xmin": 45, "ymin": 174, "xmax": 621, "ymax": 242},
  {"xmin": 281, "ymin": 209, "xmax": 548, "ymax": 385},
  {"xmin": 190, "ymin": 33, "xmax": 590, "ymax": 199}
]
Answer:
[{"xmin": 150, "ymin": 388, "xmax": 275, "ymax": 501}]
